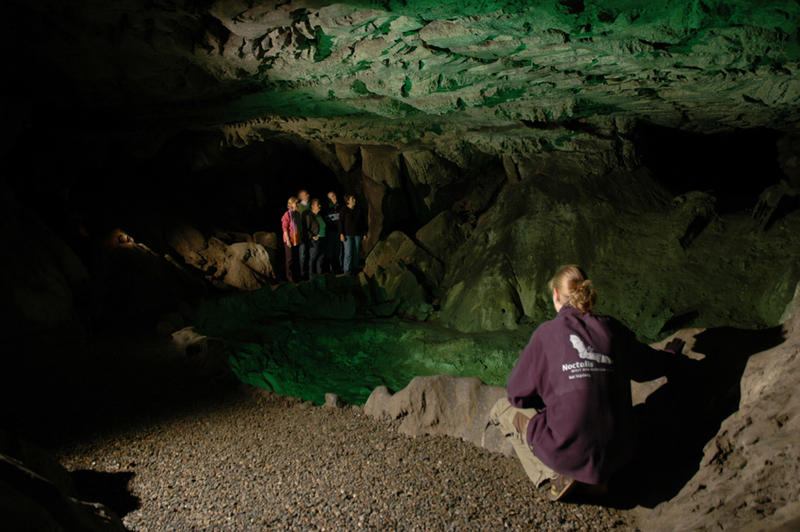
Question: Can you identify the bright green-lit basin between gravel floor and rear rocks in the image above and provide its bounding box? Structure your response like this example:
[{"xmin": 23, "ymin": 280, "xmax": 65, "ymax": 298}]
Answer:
[{"xmin": 203, "ymin": 320, "xmax": 529, "ymax": 404}]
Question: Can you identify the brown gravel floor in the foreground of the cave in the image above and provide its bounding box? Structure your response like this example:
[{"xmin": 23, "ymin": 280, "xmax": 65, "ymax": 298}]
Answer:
[{"xmin": 57, "ymin": 388, "xmax": 635, "ymax": 531}]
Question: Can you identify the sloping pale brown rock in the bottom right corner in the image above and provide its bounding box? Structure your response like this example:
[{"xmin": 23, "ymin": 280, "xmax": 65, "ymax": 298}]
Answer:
[{"xmin": 643, "ymin": 285, "xmax": 800, "ymax": 530}]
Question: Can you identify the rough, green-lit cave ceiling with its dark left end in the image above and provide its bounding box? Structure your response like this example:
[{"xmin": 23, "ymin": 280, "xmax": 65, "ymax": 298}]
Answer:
[{"xmin": 4, "ymin": 0, "xmax": 800, "ymax": 150}]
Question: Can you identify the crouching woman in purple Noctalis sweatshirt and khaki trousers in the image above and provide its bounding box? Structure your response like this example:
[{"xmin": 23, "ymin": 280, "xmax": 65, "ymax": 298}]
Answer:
[{"xmin": 490, "ymin": 265, "xmax": 684, "ymax": 500}]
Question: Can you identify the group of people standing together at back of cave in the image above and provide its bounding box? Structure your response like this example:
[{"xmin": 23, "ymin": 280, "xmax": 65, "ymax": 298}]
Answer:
[{"xmin": 281, "ymin": 189, "xmax": 367, "ymax": 283}]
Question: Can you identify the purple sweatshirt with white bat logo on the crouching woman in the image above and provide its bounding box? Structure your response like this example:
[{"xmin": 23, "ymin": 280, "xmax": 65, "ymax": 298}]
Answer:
[{"xmin": 508, "ymin": 305, "xmax": 670, "ymax": 484}]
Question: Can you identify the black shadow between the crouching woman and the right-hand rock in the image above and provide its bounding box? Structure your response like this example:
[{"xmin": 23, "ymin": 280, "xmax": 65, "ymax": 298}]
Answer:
[{"xmin": 611, "ymin": 326, "xmax": 785, "ymax": 508}]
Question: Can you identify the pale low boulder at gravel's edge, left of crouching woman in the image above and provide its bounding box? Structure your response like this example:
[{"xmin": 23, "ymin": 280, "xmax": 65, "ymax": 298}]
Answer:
[{"xmin": 364, "ymin": 375, "xmax": 512, "ymax": 456}]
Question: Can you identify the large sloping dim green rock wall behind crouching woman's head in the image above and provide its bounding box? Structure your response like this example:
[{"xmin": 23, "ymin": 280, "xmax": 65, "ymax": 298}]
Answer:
[{"xmin": 441, "ymin": 166, "xmax": 800, "ymax": 341}]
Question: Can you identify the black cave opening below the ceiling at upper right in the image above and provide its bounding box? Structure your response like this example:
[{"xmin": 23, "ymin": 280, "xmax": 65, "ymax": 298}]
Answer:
[{"xmin": 633, "ymin": 122, "xmax": 786, "ymax": 214}]
